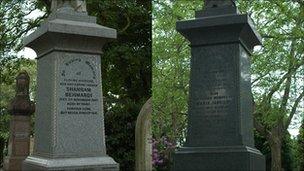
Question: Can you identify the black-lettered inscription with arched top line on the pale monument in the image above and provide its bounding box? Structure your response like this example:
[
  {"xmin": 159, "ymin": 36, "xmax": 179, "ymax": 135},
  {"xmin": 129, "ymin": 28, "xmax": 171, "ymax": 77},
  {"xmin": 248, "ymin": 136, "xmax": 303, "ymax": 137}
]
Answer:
[{"xmin": 59, "ymin": 58, "xmax": 99, "ymax": 115}]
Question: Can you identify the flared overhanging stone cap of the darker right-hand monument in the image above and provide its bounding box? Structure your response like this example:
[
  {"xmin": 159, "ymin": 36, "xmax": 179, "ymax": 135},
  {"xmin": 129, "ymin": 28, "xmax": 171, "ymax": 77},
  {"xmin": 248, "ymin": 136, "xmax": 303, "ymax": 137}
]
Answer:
[{"xmin": 176, "ymin": 14, "xmax": 262, "ymax": 54}]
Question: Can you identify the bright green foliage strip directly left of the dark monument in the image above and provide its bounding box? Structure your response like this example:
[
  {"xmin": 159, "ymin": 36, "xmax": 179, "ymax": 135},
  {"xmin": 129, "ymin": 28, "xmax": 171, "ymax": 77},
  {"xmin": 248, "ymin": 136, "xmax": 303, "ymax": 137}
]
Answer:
[{"xmin": 152, "ymin": 0, "xmax": 202, "ymax": 170}]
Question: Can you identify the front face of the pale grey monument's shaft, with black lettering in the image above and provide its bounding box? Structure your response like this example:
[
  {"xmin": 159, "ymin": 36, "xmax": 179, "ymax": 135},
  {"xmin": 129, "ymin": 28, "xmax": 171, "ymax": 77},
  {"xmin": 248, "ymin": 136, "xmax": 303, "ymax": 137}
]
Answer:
[{"xmin": 53, "ymin": 52, "xmax": 105, "ymax": 157}]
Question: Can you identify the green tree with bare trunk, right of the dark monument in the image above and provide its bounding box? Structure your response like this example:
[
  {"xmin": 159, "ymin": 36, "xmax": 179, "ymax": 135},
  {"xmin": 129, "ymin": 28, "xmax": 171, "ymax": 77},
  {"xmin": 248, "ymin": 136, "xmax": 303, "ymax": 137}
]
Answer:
[{"xmin": 239, "ymin": 0, "xmax": 304, "ymax": 171}]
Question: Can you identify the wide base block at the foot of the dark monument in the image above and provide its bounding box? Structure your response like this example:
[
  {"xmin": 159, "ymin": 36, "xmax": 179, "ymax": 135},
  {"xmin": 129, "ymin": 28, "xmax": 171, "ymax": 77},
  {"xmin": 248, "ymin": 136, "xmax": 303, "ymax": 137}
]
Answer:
[{"xmin": 173, "ymin": 146, "xmax": 265, "ymax": 171}]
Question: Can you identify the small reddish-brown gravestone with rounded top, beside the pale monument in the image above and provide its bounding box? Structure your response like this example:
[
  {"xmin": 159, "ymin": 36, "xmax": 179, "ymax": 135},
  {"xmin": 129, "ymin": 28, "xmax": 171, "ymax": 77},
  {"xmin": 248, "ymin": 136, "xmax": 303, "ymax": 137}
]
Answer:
[{"xmin": 4, "ymin": 71, "xmax": 35, "ymax": 171}]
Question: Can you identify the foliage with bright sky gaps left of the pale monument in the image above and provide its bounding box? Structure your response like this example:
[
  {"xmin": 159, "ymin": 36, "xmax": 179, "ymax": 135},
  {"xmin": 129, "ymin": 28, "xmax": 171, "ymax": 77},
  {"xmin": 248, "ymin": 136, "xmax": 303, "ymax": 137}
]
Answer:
[{"xmin": 0, "ymin": 0, "xmax": 45, "ymax": 166}]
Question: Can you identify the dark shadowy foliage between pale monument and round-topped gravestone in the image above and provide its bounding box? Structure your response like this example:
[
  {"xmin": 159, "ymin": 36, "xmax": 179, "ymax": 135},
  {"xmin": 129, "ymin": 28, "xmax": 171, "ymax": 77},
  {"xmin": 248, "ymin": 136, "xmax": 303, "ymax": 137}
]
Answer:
[{"xmin": 87, "ymin": 0, "xmax": 151, "ymax": 170}]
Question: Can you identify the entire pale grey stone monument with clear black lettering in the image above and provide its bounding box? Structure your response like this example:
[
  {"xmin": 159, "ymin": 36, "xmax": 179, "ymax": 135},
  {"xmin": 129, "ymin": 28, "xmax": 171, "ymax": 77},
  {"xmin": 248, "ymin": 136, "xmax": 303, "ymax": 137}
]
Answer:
[{"xmin": 23, "ymin": 0, "xmax": 119, "ymax": 170}]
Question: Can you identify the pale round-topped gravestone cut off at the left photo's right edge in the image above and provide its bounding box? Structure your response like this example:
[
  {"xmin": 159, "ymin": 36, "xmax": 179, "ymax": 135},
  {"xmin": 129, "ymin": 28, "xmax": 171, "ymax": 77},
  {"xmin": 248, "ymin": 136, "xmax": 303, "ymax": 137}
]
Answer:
[{"xmin": 135, "ymin": 98, "xmax": 152, "ymax": 171}]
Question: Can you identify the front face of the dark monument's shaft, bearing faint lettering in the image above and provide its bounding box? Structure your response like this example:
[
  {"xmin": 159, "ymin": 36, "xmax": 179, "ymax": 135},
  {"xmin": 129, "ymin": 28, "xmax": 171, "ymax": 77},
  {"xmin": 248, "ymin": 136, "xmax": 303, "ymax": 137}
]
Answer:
[{"xmin": 188, "ymin": 45, "xmax": 238, "ymax": 146}]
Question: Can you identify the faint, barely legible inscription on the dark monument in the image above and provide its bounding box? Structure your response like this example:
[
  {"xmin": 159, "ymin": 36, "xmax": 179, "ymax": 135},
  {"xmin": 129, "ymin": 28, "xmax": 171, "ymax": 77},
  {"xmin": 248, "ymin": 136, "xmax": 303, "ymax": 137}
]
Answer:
[{"xmin": 192, "ymin": 56, "xmax": 234, "ymax": 117}]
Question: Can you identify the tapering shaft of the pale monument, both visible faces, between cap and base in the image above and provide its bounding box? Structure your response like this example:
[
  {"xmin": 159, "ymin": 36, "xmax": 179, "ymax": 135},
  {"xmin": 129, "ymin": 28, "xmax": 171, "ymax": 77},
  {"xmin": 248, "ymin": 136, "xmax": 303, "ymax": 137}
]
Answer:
[{"xmin": 34, "ymin": 52, "xmax": 105, "ymax": 157}]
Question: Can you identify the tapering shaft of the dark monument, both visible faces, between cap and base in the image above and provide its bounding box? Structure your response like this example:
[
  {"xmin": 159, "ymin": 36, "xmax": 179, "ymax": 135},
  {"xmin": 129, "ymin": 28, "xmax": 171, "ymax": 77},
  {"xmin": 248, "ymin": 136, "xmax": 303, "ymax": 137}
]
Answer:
[{"xmin": 187, "ymin": 44, "xmax": 253, "ymax": 146}]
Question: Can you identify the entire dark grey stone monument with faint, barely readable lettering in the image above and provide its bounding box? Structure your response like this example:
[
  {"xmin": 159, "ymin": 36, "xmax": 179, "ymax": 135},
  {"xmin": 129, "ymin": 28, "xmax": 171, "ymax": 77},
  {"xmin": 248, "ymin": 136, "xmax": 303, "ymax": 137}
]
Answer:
[{"xmin": 173, "ymin": 0, "xmax": 265, "ymax": 171}]
